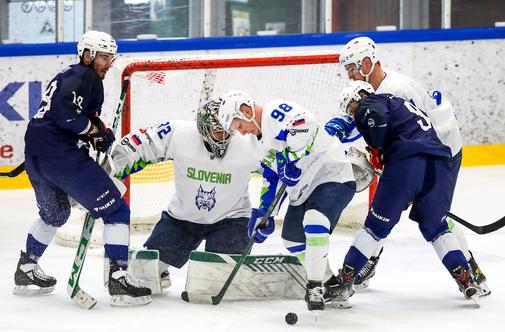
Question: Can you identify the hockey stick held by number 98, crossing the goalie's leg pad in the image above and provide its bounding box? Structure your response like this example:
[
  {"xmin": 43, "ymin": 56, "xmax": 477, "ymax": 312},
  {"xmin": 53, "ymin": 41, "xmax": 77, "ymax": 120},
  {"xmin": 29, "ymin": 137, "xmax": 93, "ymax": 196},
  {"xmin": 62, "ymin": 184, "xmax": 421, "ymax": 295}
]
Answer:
[{"xmin": 181, "ymin": 183, "xmax": 287, "ymax": 305}]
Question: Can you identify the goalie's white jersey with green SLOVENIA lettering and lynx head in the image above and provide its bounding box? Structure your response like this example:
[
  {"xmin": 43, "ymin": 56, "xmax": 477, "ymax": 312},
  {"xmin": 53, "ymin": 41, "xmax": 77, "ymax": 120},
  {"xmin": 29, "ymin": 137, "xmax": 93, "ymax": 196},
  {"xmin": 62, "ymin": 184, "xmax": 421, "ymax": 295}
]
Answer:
[{"xmin": 112, "ymin": 121, "xmax": 262, "ymax": 224}]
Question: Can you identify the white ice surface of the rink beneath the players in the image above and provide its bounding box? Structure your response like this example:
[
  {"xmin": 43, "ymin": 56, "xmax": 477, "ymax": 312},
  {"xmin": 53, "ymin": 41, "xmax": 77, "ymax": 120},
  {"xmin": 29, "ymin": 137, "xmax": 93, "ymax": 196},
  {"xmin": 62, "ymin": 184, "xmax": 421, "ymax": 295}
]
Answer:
[{"xmin": 0, "ymin": 166, "xmax": 505, "ymax": 332}]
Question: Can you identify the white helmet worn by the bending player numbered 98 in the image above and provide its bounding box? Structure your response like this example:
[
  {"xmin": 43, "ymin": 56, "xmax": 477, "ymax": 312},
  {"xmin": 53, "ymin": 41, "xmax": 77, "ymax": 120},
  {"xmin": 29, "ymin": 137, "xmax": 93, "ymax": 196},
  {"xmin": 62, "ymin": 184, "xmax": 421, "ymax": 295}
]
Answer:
[{"xmin": 218, "ymin": 90, "xmax": 256, "ymax": 132}]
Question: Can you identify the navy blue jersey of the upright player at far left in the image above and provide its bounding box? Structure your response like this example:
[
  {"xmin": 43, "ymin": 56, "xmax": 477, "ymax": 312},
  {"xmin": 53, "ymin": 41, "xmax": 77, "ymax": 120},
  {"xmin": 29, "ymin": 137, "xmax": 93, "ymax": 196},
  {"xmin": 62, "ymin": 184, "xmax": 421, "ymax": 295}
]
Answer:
[{"xmin": 25, "ymin": 64, "xmax": 103, "ymax": 155}]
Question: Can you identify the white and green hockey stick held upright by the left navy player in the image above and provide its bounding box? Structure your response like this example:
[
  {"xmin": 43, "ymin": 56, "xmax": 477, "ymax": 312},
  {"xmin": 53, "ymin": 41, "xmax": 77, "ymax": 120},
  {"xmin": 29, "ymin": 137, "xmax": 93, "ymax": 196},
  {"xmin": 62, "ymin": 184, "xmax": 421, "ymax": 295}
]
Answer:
[{"xmin": 67, "ymin": 77, "xmax": 130, "ymax": 309}]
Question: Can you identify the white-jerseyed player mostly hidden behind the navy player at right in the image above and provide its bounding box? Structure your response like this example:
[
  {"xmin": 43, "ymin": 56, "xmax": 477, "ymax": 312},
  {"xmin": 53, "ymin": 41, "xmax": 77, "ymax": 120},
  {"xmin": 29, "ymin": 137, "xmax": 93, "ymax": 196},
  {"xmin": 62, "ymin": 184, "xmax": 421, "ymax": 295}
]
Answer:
[{"xmin": 326, "ymin": 37, "xmax": 490, "ymax": 295}]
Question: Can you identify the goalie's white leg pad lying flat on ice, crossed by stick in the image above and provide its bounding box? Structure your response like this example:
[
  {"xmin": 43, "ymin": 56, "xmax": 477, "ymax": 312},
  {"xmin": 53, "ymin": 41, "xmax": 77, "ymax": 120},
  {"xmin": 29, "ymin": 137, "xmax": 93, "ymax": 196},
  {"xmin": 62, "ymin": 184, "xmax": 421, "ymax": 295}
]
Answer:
[{"xmin": 185, "ymin": 251, "xmax": 306, "ymax": 301}]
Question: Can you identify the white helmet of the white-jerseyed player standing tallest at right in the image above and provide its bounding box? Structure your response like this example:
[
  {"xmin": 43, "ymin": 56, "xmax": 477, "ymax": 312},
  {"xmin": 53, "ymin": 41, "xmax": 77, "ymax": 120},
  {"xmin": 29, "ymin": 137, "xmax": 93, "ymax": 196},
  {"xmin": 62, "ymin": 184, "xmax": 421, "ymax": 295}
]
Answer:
[{"xmin": 340, "ymin": 37, "xmax": 379, "ymax": 70}]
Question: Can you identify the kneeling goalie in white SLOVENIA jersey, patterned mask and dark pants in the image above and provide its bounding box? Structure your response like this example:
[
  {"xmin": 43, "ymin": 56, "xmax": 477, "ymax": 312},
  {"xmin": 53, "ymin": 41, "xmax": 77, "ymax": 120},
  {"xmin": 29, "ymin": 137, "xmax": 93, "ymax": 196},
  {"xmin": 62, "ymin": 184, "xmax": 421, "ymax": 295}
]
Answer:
[{"xmin": 112, "ymin": 100, "xmax": 261, "ymax": 287}]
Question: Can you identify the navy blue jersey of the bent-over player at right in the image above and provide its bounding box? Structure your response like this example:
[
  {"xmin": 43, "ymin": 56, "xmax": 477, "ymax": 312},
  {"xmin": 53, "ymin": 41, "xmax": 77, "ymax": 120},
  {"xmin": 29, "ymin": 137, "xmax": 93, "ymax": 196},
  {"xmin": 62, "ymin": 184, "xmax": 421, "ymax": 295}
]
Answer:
[{"xmin": 355, "ymin": 94, "xmax": 451, "ymax": 164}]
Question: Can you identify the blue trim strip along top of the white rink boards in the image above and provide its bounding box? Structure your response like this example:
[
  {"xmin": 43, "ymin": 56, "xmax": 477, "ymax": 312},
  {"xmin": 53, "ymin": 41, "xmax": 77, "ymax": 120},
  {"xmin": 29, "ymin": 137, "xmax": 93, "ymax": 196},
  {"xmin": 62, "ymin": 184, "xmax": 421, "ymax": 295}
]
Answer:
[{"xmin": 0, "ymin": 28, "xmax": 505, "ymax": 57}]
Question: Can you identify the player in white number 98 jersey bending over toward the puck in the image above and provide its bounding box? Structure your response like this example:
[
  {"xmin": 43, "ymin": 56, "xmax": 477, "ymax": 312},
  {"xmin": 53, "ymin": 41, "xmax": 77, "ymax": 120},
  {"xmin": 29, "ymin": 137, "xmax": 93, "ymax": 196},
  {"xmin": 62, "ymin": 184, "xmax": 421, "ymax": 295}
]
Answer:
[{"xmin": 219, "ymin": 90, "xmax": 356, "ymax": 310}]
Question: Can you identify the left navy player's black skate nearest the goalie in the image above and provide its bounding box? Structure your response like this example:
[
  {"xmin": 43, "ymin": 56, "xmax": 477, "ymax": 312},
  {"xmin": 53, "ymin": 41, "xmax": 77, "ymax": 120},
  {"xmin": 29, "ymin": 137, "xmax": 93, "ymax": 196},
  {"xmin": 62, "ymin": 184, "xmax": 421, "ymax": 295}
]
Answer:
[{"xmin": 109, "ymin": 260, "xmax": 152, "ymax": 306}]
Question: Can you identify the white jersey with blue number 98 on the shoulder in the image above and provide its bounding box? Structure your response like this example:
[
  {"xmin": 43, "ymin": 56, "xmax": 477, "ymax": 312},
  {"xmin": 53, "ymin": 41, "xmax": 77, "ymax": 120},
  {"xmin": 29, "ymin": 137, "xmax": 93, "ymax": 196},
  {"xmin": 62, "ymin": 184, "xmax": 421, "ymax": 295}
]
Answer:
[{"xmin": 261, "ymin": 100, "xmax": 354, "ymax": 206}]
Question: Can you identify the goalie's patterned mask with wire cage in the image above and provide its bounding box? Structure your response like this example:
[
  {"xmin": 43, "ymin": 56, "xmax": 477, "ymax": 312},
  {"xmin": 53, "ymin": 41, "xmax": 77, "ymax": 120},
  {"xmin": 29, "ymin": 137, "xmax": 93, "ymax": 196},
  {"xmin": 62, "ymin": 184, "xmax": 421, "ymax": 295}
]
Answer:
[{"xmin": 196, "ymin": 99, "xmax": 231, "ymax": 158}]
